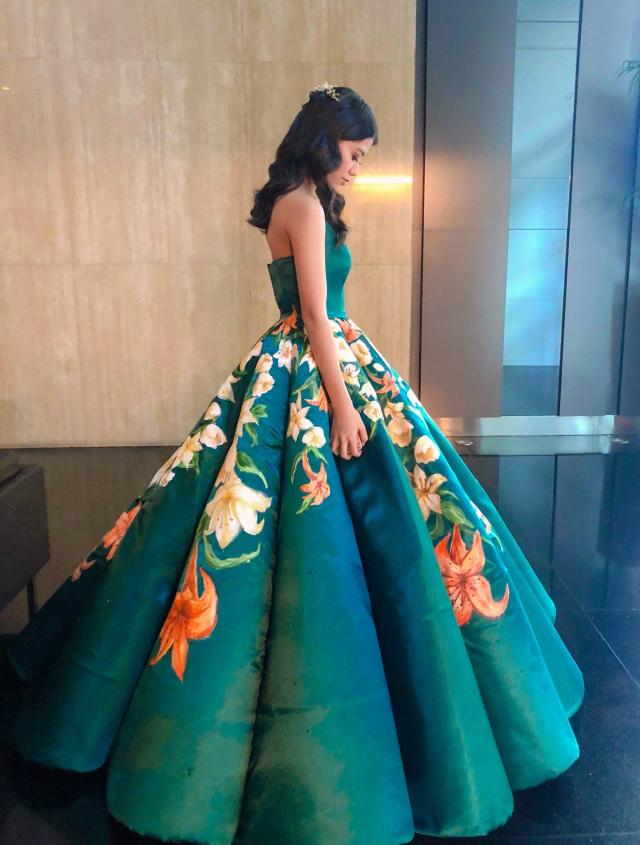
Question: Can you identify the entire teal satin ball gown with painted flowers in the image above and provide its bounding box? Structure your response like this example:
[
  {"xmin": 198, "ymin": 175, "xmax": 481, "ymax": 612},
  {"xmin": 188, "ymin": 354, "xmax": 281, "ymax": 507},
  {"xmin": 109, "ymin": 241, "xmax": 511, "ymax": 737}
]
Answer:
[{"xmin": 8, "ymin": 224, "xmax": 584, "ymax": 845}]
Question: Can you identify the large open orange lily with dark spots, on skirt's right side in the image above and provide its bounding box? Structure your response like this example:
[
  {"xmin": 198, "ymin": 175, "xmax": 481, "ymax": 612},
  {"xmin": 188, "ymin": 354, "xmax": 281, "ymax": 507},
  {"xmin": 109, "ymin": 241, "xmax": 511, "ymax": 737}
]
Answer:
[{"xmin": 434, "ymin": 525, "xmax": 509, "ymax": 625}]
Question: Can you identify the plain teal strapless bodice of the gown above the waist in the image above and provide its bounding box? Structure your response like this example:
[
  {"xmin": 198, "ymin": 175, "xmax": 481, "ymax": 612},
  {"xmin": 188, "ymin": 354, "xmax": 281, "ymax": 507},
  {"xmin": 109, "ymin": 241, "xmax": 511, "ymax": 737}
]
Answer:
[{"xmin": 267, "ymin": 221, "xmax": 351, "ymax": 317}]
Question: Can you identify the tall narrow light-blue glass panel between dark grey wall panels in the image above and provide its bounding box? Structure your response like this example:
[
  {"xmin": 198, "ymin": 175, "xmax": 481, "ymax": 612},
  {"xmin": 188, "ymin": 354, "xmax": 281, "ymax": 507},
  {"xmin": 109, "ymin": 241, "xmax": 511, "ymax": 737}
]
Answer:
[{"xmin": 502, "ymin": 0, "xmax": 579, "ymax": 415}]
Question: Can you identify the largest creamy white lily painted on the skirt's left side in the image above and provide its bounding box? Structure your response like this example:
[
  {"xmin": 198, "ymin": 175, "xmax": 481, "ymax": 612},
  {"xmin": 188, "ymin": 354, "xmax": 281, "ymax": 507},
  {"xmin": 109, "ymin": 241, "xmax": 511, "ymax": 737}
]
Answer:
[{"xmin": 205, "ymin": 473, "xmax": 271, "ymax": 549}]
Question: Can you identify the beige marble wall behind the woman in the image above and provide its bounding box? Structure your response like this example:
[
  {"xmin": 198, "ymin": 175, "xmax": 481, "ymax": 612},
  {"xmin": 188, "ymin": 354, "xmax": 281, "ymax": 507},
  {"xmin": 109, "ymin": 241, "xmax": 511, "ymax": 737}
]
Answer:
[{"xmin": 0, "ymin": 0, "xmax": 415, "ymax": 446}]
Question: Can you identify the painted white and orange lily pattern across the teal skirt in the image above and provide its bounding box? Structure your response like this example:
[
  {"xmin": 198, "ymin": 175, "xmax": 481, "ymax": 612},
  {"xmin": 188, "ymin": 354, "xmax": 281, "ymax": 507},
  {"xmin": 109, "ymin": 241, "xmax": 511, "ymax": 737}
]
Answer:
[{"xmin": 71, "ymin": 298, "xmax": 509, "ymax": 681}]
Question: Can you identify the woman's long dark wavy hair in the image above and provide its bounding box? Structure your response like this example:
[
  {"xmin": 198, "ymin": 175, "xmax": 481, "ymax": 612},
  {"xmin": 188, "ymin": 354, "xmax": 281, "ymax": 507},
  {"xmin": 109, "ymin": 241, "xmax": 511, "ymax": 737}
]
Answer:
[{"xmin": 246, "ymin": 85, "xmax": 378, "ymax": 245}]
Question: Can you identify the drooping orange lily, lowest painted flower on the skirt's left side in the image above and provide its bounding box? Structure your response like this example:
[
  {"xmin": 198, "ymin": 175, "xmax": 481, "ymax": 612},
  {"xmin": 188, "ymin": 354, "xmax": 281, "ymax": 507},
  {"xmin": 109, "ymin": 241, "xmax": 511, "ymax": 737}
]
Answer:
[{"xmin": 149, "ymin": 543, "xmax": 218, "ymax": 681}]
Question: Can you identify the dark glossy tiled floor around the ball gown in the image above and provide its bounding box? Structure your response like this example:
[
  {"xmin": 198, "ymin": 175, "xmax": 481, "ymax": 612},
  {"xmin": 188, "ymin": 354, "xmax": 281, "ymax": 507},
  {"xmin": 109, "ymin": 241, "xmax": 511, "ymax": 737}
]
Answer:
[{"xmin": 0, "ymin": 437, "xmax": 640, "ymax": 845}]
